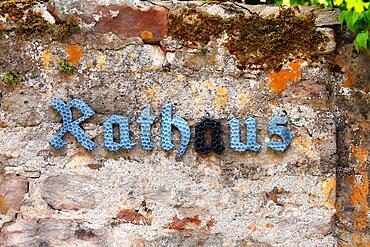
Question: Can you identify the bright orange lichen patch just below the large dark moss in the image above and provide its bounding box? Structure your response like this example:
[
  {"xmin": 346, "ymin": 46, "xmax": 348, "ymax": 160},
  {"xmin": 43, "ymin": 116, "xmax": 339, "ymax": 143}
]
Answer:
[{"xmin": 267, "ymin": 59, "xmax": 303, "ymax": 93}]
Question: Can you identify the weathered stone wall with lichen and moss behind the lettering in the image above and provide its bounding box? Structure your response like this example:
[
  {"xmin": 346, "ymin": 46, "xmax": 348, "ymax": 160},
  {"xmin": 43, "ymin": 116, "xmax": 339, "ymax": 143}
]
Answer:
[{"xmin": 0, "ymin": 0, "xmax": 370, "ymax": 246}]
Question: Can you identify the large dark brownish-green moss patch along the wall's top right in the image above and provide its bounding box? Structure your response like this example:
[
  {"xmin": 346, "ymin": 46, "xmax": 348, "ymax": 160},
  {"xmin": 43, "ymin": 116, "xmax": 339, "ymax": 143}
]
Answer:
[{"xmin": 169, "ymin": 8, "xmax": 325, "ymax": 69}]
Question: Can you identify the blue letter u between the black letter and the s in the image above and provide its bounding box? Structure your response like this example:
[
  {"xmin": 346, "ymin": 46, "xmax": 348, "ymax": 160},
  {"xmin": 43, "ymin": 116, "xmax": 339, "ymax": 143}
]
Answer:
[{"xmin": 229, "ymin": 117, "xmax": 261, "ymax": 153}]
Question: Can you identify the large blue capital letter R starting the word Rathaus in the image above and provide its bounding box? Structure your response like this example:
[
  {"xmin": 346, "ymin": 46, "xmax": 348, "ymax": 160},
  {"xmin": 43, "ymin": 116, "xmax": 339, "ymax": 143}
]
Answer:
[{"xmin": 50, "ymin": 99, "xmax": 96, "ymax": 150}]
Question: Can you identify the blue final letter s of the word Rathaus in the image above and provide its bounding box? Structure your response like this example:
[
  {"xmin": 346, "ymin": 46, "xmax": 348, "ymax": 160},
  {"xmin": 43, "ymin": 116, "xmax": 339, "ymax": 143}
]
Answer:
[{"xmin": 267, "ymin": 117, "xmax": 293, "ymax": 153}]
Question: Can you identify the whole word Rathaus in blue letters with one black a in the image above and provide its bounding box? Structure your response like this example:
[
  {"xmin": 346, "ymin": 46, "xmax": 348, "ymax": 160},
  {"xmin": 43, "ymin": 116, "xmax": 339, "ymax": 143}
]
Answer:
[{"xmin": 50, "ymin": 99, "xmax": 292, "ymax": 157}]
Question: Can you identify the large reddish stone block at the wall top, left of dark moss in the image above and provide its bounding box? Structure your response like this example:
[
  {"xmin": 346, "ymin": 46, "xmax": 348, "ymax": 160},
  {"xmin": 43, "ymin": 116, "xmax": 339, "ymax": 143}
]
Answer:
[{"xmin": 95, "ymin": 4, "xmax": 168, "ymax": 43}]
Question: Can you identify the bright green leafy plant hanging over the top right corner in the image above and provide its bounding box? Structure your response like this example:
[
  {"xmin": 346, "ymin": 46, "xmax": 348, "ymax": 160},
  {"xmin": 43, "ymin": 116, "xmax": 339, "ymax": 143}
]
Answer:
[{"xmin": 276, "ymin": 0, "xmax": 370, "ymax": 52}]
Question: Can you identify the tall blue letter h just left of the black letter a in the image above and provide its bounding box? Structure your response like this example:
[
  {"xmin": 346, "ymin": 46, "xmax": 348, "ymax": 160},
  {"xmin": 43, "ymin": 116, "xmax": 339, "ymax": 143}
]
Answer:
[{"xmin": 161, "ymin": 104, "xmax": 190, "ymax": 157}]
